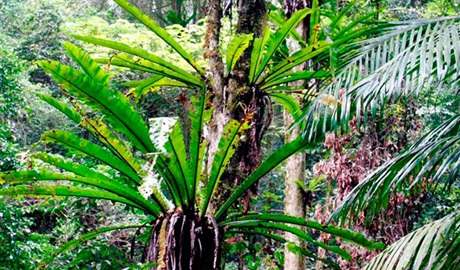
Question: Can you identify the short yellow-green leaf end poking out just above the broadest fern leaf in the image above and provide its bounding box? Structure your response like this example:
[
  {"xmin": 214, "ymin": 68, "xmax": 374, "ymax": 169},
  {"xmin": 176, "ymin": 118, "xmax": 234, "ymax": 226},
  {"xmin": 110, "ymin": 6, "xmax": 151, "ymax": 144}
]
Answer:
[{"xmin": 62, "ymin": 42, "xmax": 110, "ymax": 88}]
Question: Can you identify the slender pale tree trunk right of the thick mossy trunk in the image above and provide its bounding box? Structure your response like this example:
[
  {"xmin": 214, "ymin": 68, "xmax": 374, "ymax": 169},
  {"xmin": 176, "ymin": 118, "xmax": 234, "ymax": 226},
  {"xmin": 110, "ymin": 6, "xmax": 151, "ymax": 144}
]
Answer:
[{"xmin": 284, "ymin": 0, "xmax": 311, "ymax": 270}]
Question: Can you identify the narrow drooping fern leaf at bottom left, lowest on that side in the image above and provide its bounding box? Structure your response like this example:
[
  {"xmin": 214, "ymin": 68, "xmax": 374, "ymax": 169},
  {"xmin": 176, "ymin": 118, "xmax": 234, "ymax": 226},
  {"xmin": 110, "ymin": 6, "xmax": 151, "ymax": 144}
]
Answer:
[{"xmin": 39, "ymin": 225, "xmax": 142, "ymax": 268}]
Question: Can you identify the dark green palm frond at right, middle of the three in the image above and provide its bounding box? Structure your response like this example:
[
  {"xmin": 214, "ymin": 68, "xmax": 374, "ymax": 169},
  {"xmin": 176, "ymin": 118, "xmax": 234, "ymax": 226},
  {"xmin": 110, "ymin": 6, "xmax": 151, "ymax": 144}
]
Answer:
[{"xmin": 331, "ymin": 115, "xmax": 460, "ymax": 224}]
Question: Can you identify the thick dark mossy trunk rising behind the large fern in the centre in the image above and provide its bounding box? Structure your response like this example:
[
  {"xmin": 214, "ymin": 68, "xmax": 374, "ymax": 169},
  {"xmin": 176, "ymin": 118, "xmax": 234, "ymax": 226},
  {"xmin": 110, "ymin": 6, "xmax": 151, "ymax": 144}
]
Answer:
[{"xmin": 205, "ymin": 0, "xmax": 269, "ymax": 215}]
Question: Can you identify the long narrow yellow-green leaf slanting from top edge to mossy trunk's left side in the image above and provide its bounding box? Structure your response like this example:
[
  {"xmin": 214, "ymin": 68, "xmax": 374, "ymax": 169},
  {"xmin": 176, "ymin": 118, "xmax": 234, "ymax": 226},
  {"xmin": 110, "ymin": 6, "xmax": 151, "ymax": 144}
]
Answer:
[{"xmin": 110, "ymin": 0, "xmax": 205, "ymax": 76}]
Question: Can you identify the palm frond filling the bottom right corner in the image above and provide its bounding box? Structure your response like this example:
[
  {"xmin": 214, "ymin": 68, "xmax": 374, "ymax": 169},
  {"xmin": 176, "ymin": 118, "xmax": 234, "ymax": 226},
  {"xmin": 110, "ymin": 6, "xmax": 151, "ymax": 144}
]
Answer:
[{"xmin": 364, "ymin": 212, "xmax": 460, "ymax": 270}]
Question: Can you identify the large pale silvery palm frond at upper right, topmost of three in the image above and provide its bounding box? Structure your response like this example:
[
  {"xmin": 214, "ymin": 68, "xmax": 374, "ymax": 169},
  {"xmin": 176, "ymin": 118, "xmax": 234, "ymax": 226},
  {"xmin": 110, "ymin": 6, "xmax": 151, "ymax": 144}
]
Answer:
[{"xmin": 304, "ymin": 16, "xmax": 460, "ymax": 134}]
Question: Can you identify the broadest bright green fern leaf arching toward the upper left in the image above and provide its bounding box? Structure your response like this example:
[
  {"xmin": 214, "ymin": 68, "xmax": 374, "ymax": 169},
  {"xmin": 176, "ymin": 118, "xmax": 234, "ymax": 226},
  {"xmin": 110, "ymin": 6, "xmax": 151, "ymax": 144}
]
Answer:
[{"xmin": 38, "ymin": 61, "xmax": 155, "ymax": 153}]
